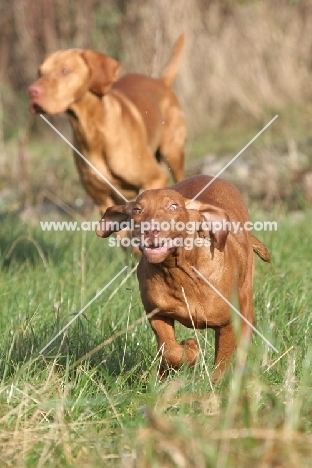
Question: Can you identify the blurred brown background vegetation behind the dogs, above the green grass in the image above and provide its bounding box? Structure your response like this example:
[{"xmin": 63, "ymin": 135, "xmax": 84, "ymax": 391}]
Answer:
[{"xmin": 0, "ymin": 0, "xmax": 312, "ymax": 215}]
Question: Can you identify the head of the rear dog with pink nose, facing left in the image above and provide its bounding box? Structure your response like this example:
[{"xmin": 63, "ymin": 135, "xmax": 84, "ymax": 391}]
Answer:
[{"xmin": 28, "ymin": 49, "xmax": 121, "ymax": 114}]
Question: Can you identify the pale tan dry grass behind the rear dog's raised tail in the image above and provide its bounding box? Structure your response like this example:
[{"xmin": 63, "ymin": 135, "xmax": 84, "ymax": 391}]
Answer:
[{"xmin": 122, "ymin": 0, "xmax": 312, "ymax": 132}]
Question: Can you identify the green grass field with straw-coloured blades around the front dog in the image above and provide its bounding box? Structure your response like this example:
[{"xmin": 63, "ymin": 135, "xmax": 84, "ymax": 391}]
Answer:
[{"xmin": 0, "ymin": 207, "xmax": 312, "ymax": 468}]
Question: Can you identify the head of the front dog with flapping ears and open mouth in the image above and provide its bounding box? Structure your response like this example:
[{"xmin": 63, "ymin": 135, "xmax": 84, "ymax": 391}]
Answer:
[{"xmin": 96, "ymin": 189, "xmax": 229, "ymax": 263}]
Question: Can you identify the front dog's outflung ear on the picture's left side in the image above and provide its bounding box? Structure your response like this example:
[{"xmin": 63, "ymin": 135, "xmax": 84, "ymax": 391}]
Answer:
[{"xmin": 96, "ymin": 202, "xmax": 134, "ymax": 237}]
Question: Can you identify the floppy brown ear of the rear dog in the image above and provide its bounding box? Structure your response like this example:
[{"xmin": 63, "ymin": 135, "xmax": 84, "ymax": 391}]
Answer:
[{"xmin": 81, "ymin": 49, "xmax": 121, "ymax": 96}]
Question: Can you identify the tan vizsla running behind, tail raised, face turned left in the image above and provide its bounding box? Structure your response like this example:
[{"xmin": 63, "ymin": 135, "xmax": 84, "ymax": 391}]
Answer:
[{"xmin": 28, "ymin": 35, "xmax": 186, "ymax": 213}]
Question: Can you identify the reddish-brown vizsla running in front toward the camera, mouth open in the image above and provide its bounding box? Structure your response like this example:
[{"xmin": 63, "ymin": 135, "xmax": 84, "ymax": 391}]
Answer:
[{"xmin": 97, "ymin": 175, "xmax": 270, "ymax": 381}]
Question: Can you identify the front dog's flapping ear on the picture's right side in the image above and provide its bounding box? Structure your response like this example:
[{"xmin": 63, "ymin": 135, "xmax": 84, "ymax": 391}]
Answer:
[{"xmin": 185, "ymin": 200, "xmax": 230, "ymax": 252}]
